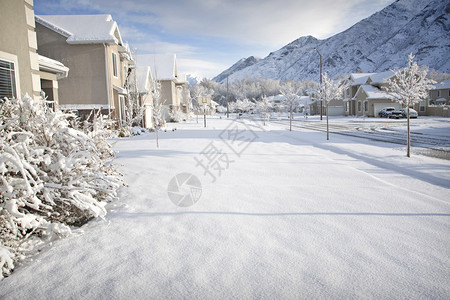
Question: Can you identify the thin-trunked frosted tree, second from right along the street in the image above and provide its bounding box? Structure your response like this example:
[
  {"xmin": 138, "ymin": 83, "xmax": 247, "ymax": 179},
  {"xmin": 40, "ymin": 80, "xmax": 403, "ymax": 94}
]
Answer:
[{"xmin": 315, "ymin": 73, "xmax": 348, "ymax": 140}]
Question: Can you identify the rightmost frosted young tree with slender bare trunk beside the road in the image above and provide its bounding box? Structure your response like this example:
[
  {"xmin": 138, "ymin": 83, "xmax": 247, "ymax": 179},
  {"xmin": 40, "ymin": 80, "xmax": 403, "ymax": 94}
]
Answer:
[{"xmin": 385, "ymin": 53, "xmax": 435, "ymax": 157}]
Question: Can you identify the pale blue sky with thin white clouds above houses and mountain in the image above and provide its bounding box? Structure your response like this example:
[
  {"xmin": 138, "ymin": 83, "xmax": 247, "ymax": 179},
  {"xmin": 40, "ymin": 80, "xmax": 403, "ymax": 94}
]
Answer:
[{"xmin": 34, "ymin": 0, "xmax": 394, "ymax": 78}]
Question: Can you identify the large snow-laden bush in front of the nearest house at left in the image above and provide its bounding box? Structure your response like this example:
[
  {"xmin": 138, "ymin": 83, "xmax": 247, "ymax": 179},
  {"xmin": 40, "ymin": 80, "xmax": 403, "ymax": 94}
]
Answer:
[{"xmin": 0, "ymin": 97, "xmax": 121, "ymax": 276}]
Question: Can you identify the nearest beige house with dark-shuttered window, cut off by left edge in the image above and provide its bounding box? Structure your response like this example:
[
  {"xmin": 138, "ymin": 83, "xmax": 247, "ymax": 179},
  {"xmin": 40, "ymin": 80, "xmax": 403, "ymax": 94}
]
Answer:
[{"xmin": 0, "ymin": 0, "xmax": 69, "ymax": 104}]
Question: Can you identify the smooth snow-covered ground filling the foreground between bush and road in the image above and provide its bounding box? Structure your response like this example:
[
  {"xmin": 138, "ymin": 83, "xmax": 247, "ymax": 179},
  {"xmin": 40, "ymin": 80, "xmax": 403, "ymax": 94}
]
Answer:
[{"xmin": 0, "ymin": 118, "xmax": 450, "ymax": 299}]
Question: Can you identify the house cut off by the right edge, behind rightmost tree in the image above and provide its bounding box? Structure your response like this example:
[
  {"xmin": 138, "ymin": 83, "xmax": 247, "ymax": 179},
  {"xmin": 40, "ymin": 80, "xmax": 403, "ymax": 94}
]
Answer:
[{"xmin": 426, "ymin": 80, "xmax": 450, "ymax": 117}]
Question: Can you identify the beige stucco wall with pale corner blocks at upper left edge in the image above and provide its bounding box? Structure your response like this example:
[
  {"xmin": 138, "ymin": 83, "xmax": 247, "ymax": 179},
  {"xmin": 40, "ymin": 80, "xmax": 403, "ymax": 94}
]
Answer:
[{"xmin": 0, "ymin": 0, "xmax": 41, "ymax": 99}]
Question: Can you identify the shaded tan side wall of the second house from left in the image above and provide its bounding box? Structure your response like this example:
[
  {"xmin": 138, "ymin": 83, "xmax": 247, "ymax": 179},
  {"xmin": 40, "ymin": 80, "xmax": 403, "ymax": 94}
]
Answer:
[{"xmin": 36, "ymin": 23, "xmax": 112, "ymax": 106}]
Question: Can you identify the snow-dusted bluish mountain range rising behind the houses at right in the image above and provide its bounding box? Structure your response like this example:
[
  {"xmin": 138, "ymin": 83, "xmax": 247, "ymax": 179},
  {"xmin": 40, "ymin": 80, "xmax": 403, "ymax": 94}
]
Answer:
[{"xmin": 214, "ymin": 0, "xmax": 450, "ymax": 83}]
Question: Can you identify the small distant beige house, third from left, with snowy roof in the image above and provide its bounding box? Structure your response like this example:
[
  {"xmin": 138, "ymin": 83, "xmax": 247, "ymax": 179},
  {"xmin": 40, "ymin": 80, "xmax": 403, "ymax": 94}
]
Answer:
[{"xmin": 145, "ymin": 54, "xmax": 187, "ymax": 120}]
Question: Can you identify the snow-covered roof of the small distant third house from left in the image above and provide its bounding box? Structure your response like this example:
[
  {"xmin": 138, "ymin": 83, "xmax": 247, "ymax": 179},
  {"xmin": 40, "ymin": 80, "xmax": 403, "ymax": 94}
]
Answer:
[{"xmin": 144, "ymin": 54, "xmax": 178, "ymax": 80}]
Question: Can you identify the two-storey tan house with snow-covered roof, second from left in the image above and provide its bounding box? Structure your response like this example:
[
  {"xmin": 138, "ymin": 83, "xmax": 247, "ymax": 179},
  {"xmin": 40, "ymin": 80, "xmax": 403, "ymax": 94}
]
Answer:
[{"xmin": 35, "ymin": 15, "xmax": 134, "ymax": 121}]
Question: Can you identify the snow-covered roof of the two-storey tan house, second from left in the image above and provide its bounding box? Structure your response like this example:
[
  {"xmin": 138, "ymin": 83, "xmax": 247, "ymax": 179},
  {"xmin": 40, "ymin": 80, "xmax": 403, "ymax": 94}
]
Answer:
[{"xmin": 35, "ymin": 15, "xmax": 122, "ymax": 45}]
